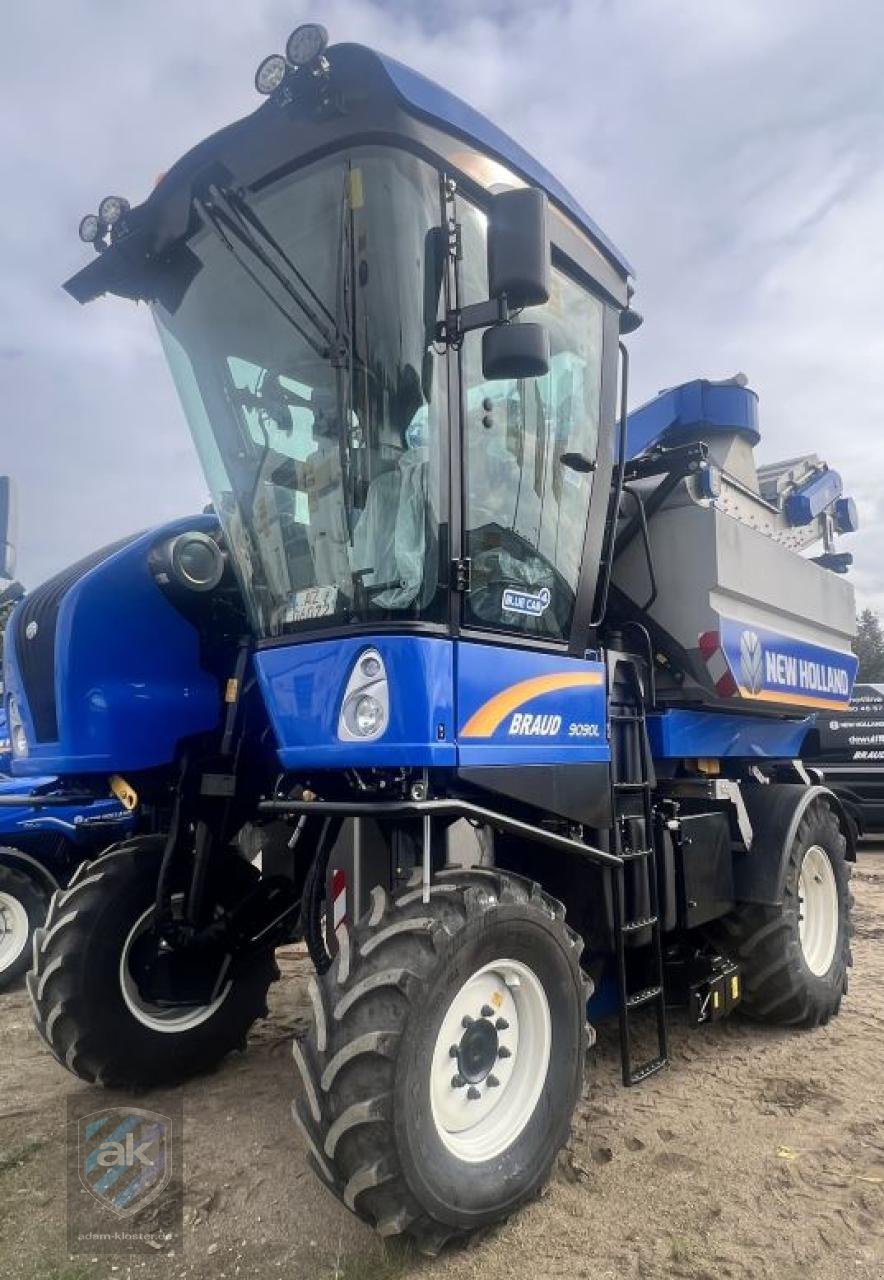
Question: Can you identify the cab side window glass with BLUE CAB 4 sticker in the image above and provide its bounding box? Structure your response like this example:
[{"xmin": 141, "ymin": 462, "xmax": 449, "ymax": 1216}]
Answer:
[{"xmin": 462, "ymin": 206, "xmax": 604, "ymax": 640}]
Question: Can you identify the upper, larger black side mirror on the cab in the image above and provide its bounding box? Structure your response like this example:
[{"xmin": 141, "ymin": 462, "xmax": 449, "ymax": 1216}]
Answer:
[{"xmin": 487, "ymin": 187, "xmax": 550, "ymax": 310}]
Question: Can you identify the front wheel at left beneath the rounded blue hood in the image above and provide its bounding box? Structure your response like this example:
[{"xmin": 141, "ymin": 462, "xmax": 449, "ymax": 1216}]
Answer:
[{"xmin": 28, "ymin": 837, "xmax": 278, "ymax": 1087}]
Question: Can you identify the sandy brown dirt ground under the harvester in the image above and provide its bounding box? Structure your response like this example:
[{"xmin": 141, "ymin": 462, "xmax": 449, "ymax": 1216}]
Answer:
[{"xmin": 0, "ymin": 847, "xmax": 884, "ymax": 1280}]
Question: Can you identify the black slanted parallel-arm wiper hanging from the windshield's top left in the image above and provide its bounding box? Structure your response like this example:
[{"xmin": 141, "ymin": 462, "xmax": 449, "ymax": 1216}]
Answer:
[{"xmin": 194, "ymin": 187, "xmax": 345, "ymax": 364}]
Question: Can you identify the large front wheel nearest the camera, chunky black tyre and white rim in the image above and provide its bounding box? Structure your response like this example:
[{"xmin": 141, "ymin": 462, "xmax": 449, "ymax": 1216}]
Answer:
[{"xmin": 294, "ymin": 869, "xmax": 588, "ymax": 1252}]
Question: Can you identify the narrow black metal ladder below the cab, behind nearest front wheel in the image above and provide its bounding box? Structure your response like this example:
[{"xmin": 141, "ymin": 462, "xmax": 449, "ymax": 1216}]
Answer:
[{"xmin": 610, "ymin": 701, "xmax": 669, "ymax": 1087}]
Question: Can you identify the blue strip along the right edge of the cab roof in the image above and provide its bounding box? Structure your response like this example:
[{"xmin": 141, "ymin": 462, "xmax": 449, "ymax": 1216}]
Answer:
[{"xmin": 377, "ymin": 54, "xmax": 636, "ymax": 276}]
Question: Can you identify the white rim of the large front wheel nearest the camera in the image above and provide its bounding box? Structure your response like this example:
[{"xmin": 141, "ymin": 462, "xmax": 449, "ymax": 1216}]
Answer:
[{"xmin": 430, "ymin": 960, "xmax": 553, "ymax": 1164}]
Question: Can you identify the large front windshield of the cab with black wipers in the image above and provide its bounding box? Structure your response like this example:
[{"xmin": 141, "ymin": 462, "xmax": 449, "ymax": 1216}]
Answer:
[{"xmin": 155, "ymin": 148, "xmax": 448, "ymax": 636}]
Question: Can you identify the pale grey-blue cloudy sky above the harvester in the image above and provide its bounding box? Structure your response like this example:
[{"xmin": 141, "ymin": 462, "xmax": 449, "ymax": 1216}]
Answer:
[{"xmin": 0, "ymin": 0, "xmax": 884, "ymax": 608}]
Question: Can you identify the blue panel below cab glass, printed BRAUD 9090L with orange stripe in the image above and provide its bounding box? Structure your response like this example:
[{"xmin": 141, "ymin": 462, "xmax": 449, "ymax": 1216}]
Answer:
[{"xmin": 255, "ymin": 635, "xmax": 609, "ymax": 769}]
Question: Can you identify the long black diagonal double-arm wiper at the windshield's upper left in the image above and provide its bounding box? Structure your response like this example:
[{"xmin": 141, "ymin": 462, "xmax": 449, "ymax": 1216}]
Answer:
[{"xmin": 193, "ymin": 186, "xmax": 348, "ymax": 366}]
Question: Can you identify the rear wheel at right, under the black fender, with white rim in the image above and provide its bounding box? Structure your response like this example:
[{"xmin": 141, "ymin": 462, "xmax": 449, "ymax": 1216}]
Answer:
[{"xmin": 714, "ymin": 800, "xmax": 852, "ymax": 1027}]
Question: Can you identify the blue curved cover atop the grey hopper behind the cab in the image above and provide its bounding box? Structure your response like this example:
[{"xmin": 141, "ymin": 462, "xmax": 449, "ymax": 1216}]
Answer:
[{"xmin": 627, "ymin": 378, "xmax": 761, "ymax": 458}]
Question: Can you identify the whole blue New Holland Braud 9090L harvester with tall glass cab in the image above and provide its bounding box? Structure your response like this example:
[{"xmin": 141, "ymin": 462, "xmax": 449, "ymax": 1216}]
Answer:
[{"xmin": 5, "ymin": 24, "xmax": 856, "ymax": 1251}]
